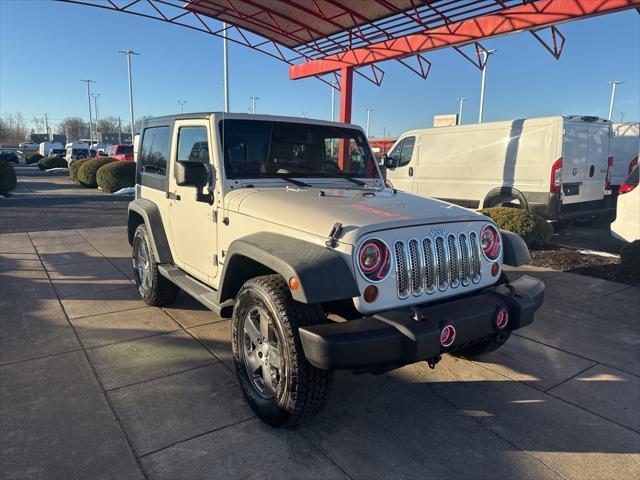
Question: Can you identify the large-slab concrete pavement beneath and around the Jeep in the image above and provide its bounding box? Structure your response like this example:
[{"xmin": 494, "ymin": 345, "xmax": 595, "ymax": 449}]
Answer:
[{"xmin": 0, "ymin": 227, "xmax": 640, "ymax": 479}]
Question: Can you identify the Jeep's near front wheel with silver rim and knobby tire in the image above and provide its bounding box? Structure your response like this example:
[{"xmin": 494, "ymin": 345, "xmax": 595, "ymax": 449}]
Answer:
[{"xmin": 232, "ymin": 275, "xmax": 333, "ymax": 427}]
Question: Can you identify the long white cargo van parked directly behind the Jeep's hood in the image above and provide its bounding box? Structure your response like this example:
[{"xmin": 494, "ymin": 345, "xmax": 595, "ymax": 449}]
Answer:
[{"xmin": 384, "ymin": 116, "xmax": 615, "ymax": 221}]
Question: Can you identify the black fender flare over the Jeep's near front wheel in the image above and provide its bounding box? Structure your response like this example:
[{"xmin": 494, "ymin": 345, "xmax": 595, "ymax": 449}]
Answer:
[{"xmin": 219, "ymin": 232, "xmax": 360, "ymax": 303}]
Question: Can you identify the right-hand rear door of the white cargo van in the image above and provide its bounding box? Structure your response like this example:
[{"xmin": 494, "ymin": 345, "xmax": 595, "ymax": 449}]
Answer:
[{"xmin": 582, "ymin": 122, "xmax": 611, "ymax": 202}]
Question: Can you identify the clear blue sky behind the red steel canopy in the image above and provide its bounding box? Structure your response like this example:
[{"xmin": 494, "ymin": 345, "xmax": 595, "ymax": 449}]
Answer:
[{"xmin": 0, "ymin": 0, "xmax": 640, "ymax": 136}]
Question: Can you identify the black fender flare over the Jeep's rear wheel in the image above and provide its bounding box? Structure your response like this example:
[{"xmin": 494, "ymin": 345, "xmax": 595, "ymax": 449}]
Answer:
[{"xmin": 127, "ymin": 198, "xmax": 173, "ymax": 263}]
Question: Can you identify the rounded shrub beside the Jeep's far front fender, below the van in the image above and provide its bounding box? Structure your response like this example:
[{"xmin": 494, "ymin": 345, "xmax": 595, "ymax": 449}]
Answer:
[{"xmin": 480, "ymin": 207, "xmax": 553, "ymax": 249}]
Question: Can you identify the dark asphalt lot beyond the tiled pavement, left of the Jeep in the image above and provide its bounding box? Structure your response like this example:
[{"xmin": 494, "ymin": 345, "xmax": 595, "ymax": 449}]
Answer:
[{"xmin": 0, "ymin": 166, "xmax": 131, "ymax": 233}]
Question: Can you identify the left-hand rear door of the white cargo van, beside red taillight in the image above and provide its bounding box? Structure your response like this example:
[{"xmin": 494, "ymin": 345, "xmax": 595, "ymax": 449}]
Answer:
[{"xmin": 562, "ymin": 122, "xmax": 588, "ymax": 204}]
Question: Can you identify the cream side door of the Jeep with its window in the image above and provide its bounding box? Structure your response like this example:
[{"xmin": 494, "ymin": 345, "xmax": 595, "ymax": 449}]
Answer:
[{"xmin": 167, "ymin": 119, "xmax": 218, "ymax": 281}]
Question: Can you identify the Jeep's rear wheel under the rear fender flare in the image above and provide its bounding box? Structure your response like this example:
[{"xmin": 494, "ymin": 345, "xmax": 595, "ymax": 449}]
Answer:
[{"xmin": 133, "ymin": 223, "xmax": 180, "ymax": 307}]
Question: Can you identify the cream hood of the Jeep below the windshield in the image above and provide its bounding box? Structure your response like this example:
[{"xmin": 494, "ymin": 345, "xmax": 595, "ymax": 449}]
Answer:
[{"xmin": 225, "ymin": 187, "xmax": 490, "ymax": 244}]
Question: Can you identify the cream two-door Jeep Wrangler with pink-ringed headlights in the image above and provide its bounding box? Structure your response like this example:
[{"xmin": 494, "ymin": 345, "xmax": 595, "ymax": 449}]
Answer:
[{"xmin": 128, "ymin": 113, "xmax": 544, "ymax": 426}]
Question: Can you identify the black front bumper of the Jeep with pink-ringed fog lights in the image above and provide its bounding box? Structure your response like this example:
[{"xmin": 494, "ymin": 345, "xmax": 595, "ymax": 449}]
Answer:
[{"xmin": 300, "ymin": 276, "xmax": 545, "ymax": 370}]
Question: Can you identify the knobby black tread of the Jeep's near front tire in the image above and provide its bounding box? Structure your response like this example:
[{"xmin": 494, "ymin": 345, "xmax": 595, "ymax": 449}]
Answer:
[{"xmin": 233, "ymin": 275, "xmax": 333, "ymax": 427}]
